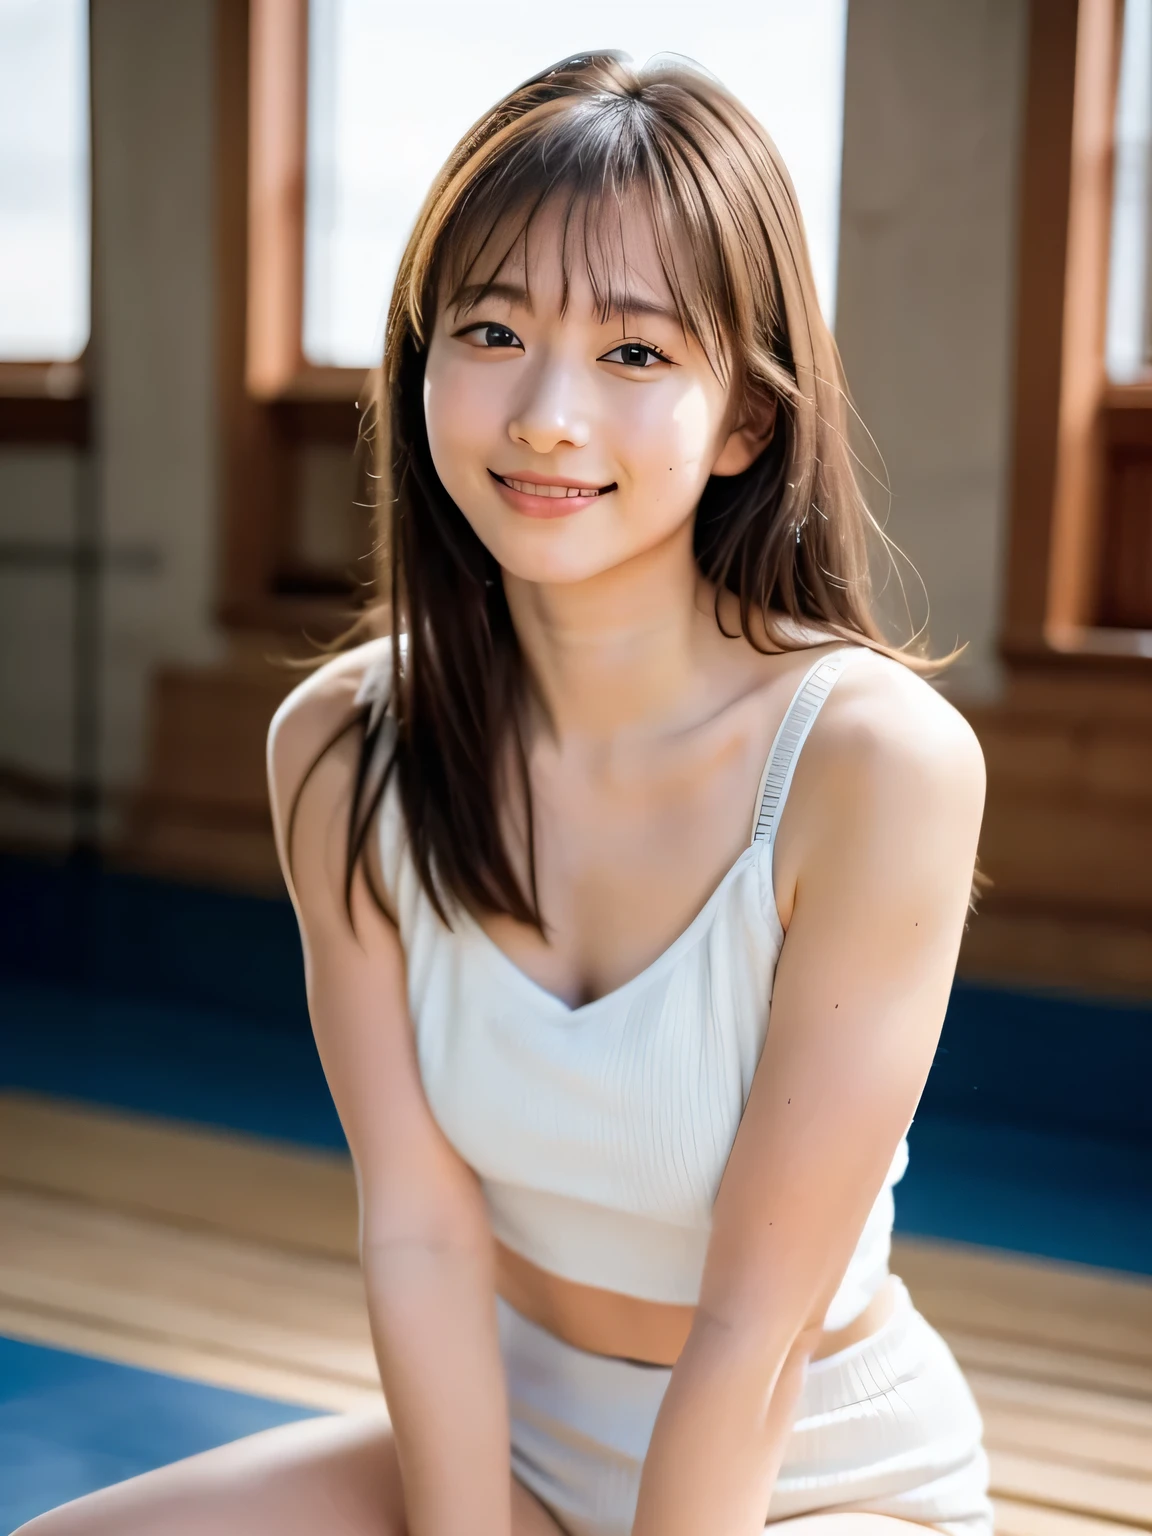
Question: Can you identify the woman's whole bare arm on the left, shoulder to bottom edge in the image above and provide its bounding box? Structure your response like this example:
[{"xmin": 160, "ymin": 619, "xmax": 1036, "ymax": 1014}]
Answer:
[{"xmin": 269, "ymin": 647, "xmax": 511, "ymax": 1536}]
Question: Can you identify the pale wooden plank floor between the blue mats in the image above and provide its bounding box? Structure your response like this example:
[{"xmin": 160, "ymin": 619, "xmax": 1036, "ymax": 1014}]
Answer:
[{"xmin": 0, "ymin": 1095, "xmax": 1152, "ymax": 1536}]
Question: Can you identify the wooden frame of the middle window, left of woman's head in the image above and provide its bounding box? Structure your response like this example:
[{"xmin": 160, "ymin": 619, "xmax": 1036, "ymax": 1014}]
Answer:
[{"xmin": 215, "ymin": 0, "xmax": 364, "ymax": 639}]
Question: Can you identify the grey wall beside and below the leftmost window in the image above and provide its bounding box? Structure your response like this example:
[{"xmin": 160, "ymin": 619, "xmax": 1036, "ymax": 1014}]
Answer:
[{"xmin": 0, "ymin": 0, "xmax": 218, "ymax": 842}]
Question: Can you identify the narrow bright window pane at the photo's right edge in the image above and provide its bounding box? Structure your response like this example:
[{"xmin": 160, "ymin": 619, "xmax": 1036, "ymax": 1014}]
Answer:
[{"xmin": 1106, "ymin": 0, "xmax": 1152, "ymax": 384}]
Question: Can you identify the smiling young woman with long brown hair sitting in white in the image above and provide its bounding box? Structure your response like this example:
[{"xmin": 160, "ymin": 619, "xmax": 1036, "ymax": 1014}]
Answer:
[{"xmin": 31, "ymin": 55, "xmax": 991, "ymax": 1536}]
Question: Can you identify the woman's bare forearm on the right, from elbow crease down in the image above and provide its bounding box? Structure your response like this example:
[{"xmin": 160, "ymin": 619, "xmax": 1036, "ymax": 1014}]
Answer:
[{"xmin": 633, "ymin": 1327, "xmax": 808, "ymax": 1536}]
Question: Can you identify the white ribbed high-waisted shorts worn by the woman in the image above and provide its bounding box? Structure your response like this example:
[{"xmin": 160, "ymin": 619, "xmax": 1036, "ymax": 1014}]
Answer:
[{"xmin": 498, "ymin": 1279, "xmax": 992, "ymax": 1536}]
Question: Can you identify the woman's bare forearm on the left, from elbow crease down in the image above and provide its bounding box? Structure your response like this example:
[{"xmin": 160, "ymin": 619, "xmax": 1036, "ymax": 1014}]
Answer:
[{"xmin": 361, "ymin": 1243, "xmax": 511, "ymax": 1536}]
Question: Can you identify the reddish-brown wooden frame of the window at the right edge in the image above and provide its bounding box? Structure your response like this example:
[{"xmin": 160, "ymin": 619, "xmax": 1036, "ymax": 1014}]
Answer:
[{"xmin": 1001, "ymin": 0, "xmax": 1152, "ymax": 676}]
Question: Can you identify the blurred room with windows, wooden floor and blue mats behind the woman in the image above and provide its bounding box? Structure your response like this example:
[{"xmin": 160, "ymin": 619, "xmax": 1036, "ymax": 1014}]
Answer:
[{"xmin": 0, "ymin": 0, "xmax": 1152, "ymax": 1536}]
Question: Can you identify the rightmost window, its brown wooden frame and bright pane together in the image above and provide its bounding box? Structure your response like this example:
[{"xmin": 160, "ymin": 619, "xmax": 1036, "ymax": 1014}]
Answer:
[{"xmin": 1003, "ymin": 0, "xmax": 1152, "ymax": 645}]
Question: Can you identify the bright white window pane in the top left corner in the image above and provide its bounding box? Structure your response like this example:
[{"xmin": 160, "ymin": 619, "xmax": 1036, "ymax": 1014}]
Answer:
[{"xmin": 0, "ymin": 0, "xmax": 91, "ymax": 362}]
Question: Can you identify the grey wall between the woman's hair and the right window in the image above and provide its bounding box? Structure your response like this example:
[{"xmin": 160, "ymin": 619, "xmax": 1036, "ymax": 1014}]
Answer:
[{"xmin": 836, "ymin": 0, "xmax": 1028, "ymax": 699}]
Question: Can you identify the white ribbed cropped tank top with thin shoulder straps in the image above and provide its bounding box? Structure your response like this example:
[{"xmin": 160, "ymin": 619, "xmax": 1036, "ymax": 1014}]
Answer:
[{"xmin": 359, "ymin": 647, "xmax": 908, "ymax": 1329}]
